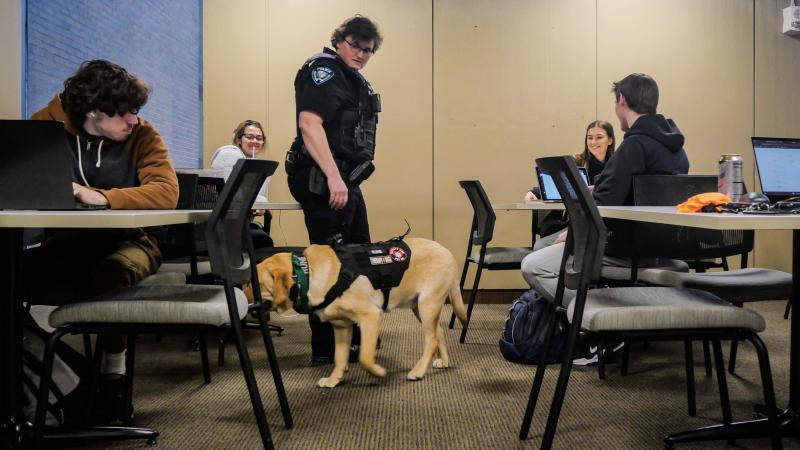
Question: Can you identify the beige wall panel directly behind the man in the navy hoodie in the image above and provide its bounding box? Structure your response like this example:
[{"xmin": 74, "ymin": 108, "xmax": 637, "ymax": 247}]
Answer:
[{"xmin": 597, "ymin": 0, "xmax": 753, "ymax": 179}]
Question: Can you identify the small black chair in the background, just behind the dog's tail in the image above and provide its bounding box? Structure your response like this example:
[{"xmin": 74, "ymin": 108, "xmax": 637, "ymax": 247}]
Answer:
[{"xmin": 449, "ymin": 180, "xmax": 533, "ymax": 344}]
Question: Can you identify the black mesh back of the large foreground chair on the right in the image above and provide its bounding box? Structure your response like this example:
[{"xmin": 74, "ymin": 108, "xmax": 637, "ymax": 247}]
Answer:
[{"xmin": 536, "ymin": 156, "xmax": 606, "ymax": 289}]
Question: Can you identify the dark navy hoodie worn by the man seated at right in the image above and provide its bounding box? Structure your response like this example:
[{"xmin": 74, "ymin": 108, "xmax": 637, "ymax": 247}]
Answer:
[{"xmin": 593, "ymin": 114, "xmax": 689, "ymax": 256}]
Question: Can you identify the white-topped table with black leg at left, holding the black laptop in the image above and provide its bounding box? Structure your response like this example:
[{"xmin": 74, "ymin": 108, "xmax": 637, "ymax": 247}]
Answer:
[{"xmin": 0, "ymin": 210, "xmax": 211, "ymax": 448}]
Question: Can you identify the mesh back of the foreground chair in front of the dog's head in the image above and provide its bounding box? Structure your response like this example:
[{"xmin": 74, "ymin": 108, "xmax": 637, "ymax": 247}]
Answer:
[{"xmin": 206, "ymin": 159, "xmax": 278, "ymax": 284}]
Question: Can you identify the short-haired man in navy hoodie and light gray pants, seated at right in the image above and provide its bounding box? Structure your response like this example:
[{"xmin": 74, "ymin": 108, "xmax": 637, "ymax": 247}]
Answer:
[{"xmin": 522, "ymin": 73, "xmax": 689, "ymax": 365}]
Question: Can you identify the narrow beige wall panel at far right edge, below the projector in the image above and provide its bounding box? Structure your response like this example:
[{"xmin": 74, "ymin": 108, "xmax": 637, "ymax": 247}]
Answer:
[{"xmin": 755, "ymin": 0, "xmax": 800, "ymax": 271}]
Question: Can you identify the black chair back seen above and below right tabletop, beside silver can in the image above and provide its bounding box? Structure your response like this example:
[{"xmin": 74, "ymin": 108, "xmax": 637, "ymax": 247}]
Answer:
[{"xmin": 633, "ymin": 175, "xmax": 753, "ymax": 260}]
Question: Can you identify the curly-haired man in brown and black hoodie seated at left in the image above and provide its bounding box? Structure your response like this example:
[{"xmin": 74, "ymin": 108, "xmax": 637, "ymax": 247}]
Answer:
[{"xmin": 23, "ymin": 60, "xmax": 178, "ymax": 419}]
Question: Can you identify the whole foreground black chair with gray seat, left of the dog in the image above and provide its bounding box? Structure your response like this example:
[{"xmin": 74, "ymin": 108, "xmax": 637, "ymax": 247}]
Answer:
[{"xmin": 34, "ymin": 159, "xmax": 293, "ymax": 449}]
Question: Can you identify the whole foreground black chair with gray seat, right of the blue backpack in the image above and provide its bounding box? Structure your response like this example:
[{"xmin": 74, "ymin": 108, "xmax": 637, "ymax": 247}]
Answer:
[{"xmin": 519, "ymin": 156, "xmax": 781, "ymax": 449}]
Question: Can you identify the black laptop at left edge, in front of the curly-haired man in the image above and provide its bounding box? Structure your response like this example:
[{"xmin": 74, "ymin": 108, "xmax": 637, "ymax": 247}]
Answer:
[{"xmin": 0, "ymin": 120, "xmax": 105, "ymax": 211}]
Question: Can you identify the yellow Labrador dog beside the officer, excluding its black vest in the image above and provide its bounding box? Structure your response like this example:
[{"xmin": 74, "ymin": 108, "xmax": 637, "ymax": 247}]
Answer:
[{"xmin": 245, "ymin": 238, "xmax": 467, "ymax": 388}]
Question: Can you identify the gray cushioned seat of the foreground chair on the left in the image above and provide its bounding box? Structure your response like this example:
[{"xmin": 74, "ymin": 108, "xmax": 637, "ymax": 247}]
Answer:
[{"xmin": 50, "ymin": 285, "xmax": 247, "ymax": 328}]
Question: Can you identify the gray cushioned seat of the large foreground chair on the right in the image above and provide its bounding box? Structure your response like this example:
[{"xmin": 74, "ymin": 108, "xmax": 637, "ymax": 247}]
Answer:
[{"xmin": 567, "ymin": 287, "xmax": 766, "ymax": 332}]
